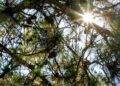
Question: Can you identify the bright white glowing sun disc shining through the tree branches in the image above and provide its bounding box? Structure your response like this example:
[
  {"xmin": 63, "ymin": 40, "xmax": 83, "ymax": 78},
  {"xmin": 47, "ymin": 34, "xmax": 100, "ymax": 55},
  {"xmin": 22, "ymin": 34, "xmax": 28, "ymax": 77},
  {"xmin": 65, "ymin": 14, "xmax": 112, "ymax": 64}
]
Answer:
[{"xmin": 82, "ymin": 12, "xmax": 94, "ymax": 23}]
